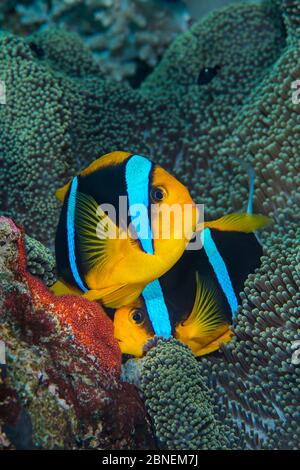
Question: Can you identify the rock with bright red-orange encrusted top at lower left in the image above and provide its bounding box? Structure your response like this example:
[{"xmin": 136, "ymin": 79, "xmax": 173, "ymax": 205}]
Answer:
[{"xmin": 0, "ymin": 217, "xmax": 152, "ymax": 449}]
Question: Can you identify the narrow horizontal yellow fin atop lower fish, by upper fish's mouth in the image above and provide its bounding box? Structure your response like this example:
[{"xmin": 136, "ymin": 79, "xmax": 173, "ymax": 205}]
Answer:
[{"xmin": 202, "ymin": 213, "xmax": 273, "ymax": 233}]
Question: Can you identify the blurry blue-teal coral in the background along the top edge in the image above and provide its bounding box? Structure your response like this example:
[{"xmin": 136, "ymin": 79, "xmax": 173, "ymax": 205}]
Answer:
[{"xmin": 0, "ymin": 0, "xmax": 190, "ymax": 80}]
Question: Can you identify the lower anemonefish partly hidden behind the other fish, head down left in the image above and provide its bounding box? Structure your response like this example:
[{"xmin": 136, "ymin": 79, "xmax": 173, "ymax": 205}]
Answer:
[{"xmin": 114, "ymin": 214, "xmax": 270, "ymax": 357}]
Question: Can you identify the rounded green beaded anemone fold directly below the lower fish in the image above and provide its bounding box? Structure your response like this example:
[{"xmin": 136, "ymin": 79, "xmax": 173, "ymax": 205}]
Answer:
[{"xmin": 123, "ymin": 339, "xmax": 241, "ymax": 450}]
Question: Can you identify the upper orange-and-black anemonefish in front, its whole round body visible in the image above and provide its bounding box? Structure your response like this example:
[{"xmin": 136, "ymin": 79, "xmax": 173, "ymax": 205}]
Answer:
[{"xmin": 52, "ymin": 152, "xmax": 198, "ymax": 308}]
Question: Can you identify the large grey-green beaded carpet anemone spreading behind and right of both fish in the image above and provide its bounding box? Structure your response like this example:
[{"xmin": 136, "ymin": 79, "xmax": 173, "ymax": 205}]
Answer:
[{"xmin": 0, "ymin": 0, "xmax": 300, "ymax": 449}]
